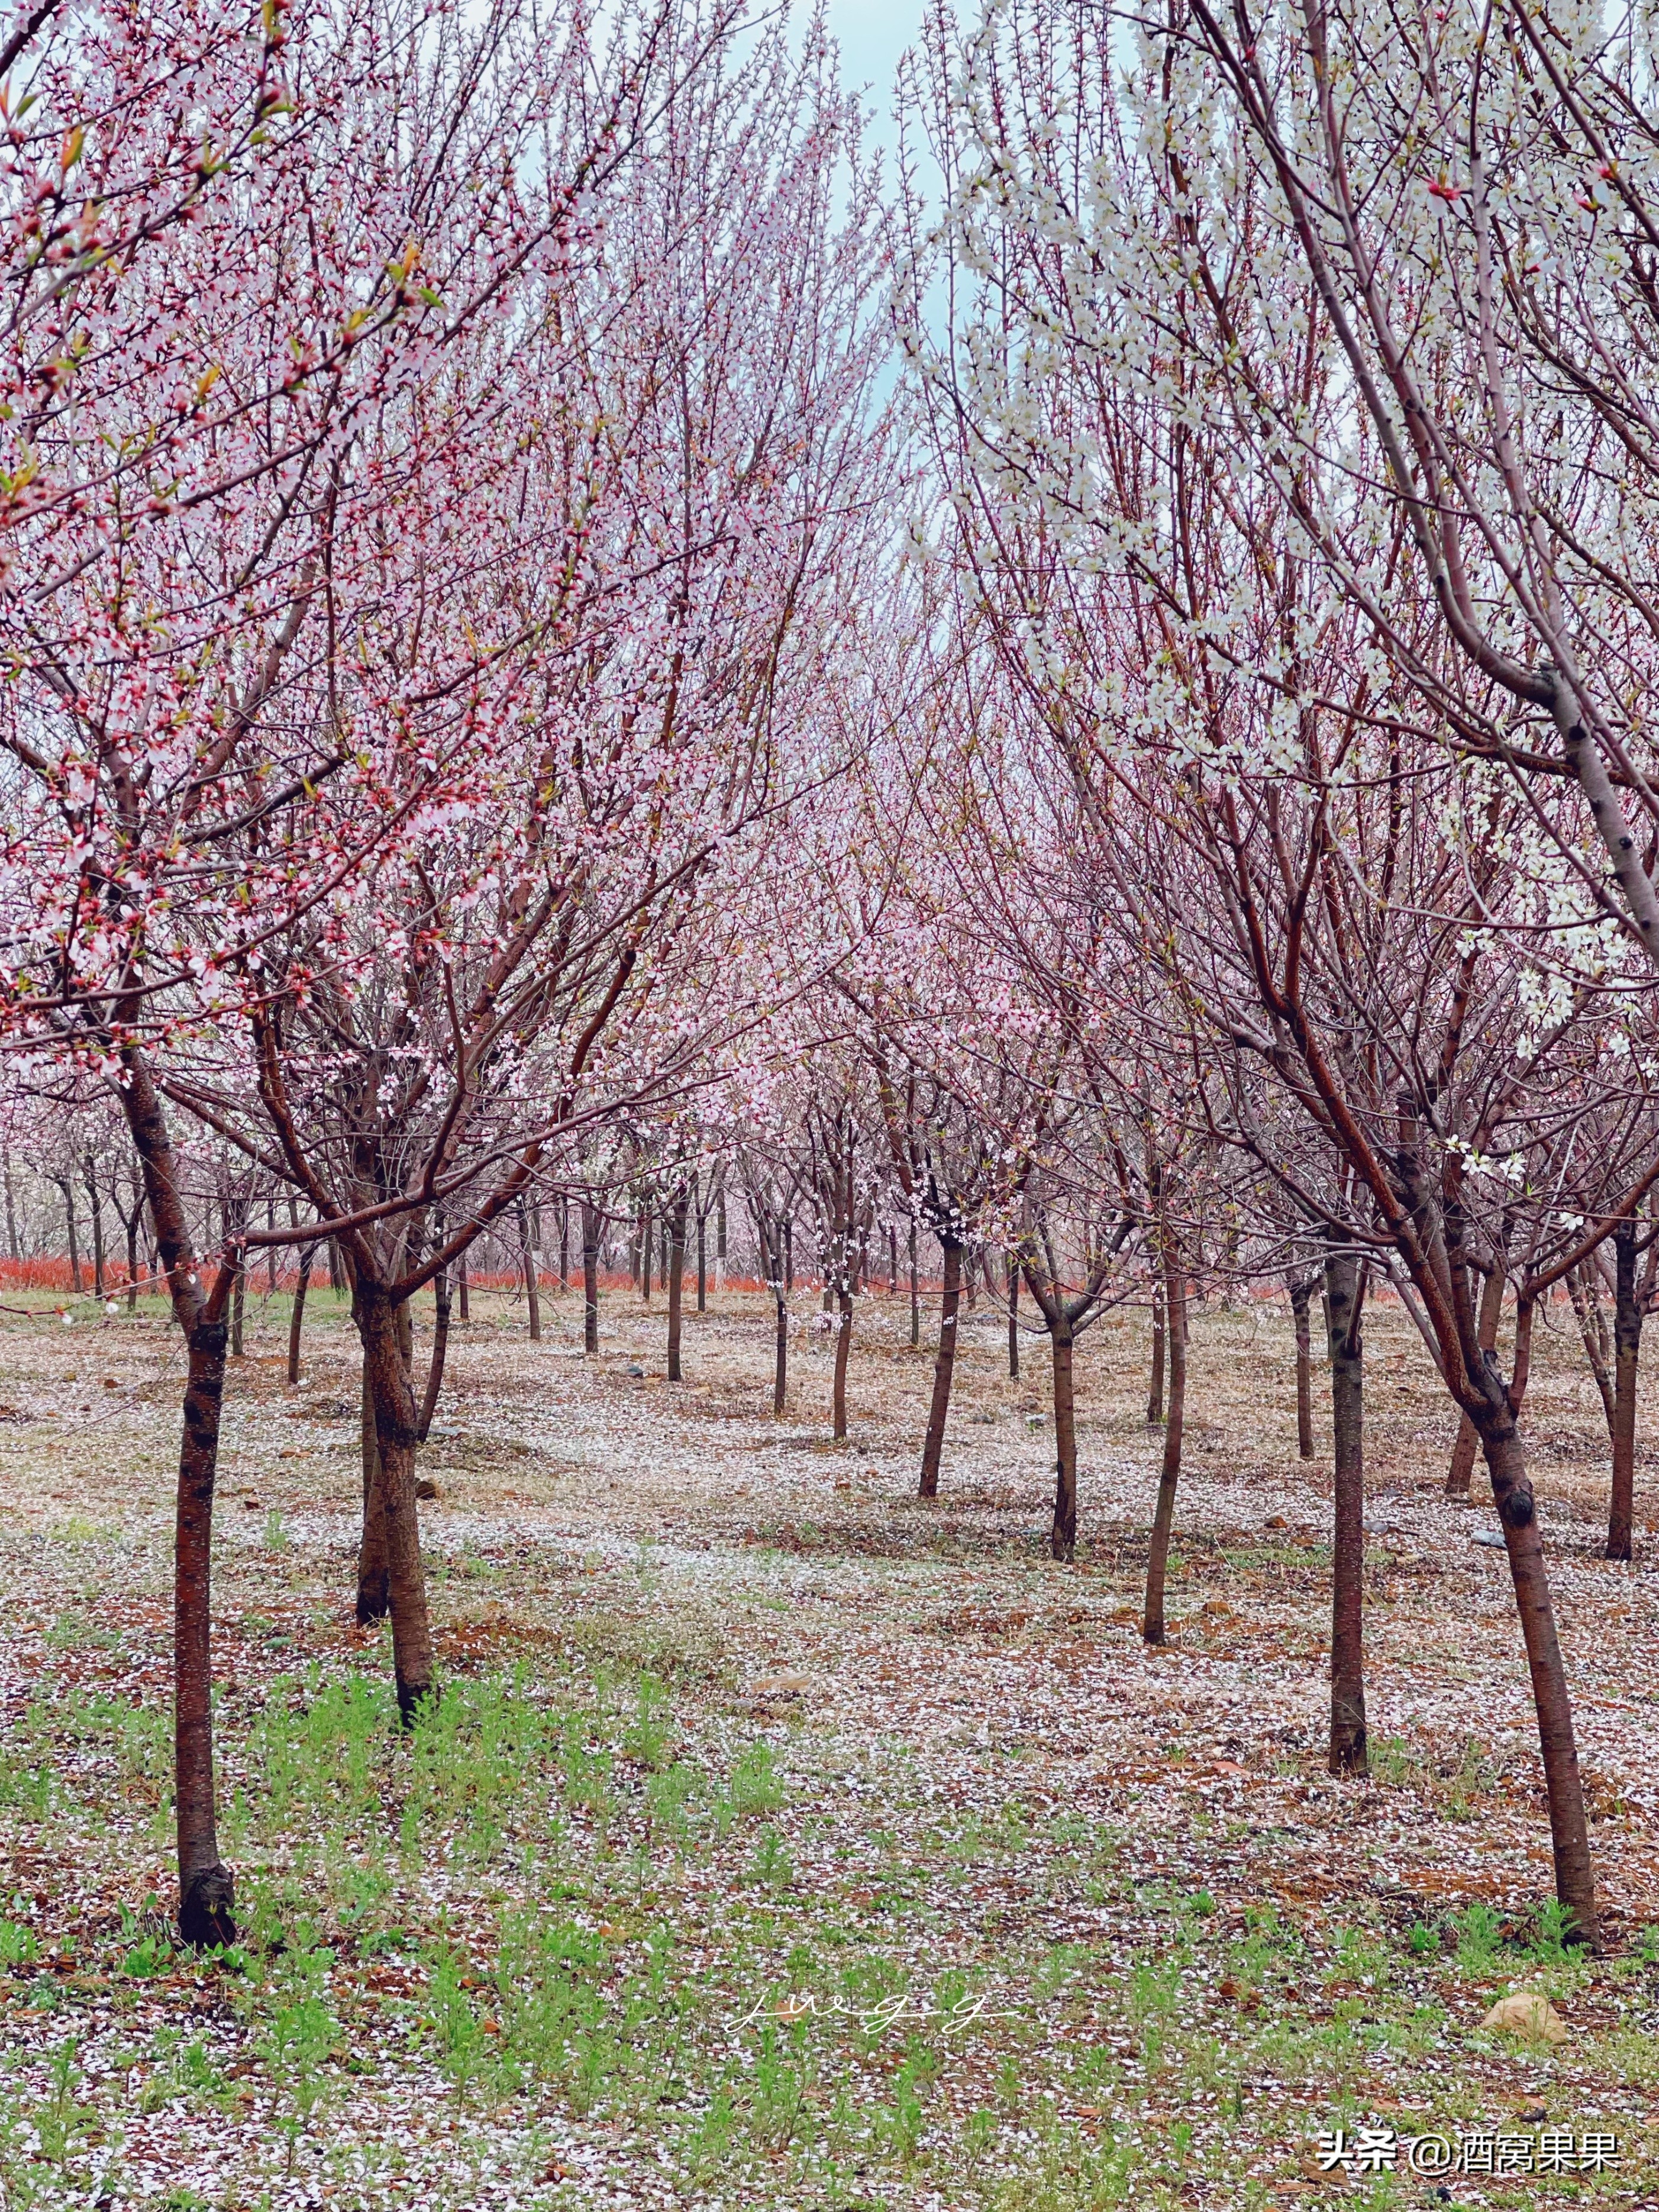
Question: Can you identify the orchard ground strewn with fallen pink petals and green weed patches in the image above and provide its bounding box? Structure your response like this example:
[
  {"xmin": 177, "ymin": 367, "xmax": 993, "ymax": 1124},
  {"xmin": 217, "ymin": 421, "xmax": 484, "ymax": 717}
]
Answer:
[{"xmin": 0, "ymin": 1292, "xmax": 1659, "ymax": 2212}]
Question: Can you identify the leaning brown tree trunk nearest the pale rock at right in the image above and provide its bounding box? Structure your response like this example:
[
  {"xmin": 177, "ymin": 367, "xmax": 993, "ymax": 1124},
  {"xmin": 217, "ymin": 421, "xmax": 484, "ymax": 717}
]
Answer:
[{"xmin": 1480, "ymin": 1405, "xmax": 1599, "ymax": 1951}]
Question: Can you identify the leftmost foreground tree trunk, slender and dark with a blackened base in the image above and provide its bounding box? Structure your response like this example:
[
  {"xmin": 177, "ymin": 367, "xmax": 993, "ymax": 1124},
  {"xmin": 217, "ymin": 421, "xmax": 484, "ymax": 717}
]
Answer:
[{"xmin": 120, "ymin": 1046, "xmax": 237, "ymax": 1946}]
